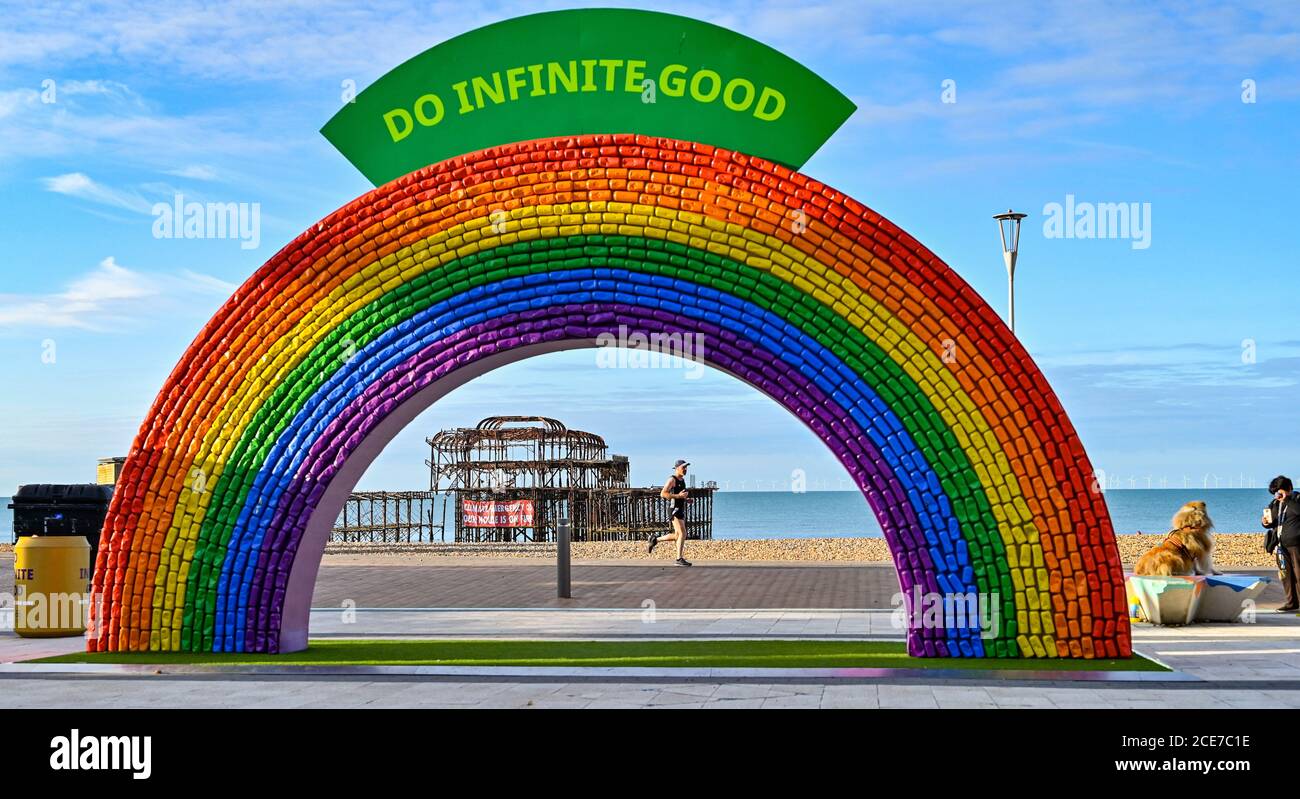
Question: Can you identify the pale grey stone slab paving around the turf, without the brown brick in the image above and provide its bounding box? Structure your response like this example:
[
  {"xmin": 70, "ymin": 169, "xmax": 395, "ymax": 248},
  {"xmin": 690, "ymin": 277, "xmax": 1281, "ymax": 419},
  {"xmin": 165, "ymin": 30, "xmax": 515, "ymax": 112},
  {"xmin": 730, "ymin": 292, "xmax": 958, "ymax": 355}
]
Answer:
[{"xmin": 0, "ymin": 609, "xmax": 1300, "ymax": 708}]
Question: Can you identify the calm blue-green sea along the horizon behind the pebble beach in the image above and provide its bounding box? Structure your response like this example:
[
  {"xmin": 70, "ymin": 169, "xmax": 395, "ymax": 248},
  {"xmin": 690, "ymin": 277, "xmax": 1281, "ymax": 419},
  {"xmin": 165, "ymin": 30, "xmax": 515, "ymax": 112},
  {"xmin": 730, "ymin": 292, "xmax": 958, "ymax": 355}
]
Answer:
[{"xmin": 0, "ymin": 488, "xmax": 1269, "ymax": 540}]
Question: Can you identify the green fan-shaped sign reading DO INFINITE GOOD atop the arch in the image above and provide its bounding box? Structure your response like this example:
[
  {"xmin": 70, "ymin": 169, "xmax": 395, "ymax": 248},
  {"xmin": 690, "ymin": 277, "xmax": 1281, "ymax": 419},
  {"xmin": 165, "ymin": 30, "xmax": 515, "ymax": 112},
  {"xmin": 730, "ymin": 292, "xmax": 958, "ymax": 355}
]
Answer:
[{"xmin": 321, "ymin": 9, "xmax": 854, "ymax": 186}]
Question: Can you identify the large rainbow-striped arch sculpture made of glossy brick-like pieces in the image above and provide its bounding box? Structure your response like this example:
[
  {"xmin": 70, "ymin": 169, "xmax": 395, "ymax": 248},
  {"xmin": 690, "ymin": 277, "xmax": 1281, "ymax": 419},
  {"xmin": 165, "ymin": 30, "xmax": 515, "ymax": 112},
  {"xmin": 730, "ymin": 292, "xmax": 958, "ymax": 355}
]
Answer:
[{"xmin": 88, "ymin": 135, "xmax": 1131, "ymax": 657}]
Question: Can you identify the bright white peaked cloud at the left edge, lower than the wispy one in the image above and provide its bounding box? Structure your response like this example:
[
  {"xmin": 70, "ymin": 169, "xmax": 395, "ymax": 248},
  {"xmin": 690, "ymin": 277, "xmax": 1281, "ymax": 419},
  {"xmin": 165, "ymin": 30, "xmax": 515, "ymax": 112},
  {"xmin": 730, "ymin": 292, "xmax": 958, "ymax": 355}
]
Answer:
[{"xmin": 0, "ymin": 256, "xmax": 235, "ymax": 330}]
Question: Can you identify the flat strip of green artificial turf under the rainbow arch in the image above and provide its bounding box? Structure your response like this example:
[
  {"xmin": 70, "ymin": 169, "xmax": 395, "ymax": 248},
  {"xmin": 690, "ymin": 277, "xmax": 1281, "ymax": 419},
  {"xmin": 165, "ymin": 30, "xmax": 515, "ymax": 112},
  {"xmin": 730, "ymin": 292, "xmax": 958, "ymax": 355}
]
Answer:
[{"xmin": 27, "ymin": 639, "xmax": 1169, "ymax": 672}]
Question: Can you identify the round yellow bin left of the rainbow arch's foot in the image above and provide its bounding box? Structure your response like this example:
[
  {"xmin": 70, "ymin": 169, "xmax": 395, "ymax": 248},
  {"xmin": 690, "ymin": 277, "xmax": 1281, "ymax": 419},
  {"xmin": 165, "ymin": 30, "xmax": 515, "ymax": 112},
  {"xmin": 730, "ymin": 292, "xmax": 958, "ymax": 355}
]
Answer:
[{"xmin": 13, "ymin": 535, "xmax": 91, "ymax": 638}]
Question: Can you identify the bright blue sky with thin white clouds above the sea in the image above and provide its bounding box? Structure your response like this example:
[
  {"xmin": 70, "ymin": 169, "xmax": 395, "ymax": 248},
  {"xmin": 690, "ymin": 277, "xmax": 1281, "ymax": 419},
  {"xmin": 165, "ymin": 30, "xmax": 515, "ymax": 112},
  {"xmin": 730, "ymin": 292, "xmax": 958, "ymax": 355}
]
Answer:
[{"xmin": 0, "ymin": 0, "xmax": 1300, "ymax": 494}]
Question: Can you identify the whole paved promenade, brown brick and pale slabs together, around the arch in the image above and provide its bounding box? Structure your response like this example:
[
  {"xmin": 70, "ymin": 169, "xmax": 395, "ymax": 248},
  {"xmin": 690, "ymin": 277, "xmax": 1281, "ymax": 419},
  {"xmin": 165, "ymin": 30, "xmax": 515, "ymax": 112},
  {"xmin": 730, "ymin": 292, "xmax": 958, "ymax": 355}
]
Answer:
[{"xmin": 0, "ymin": 561, "xmax": 1300, "ymax": 708}]
